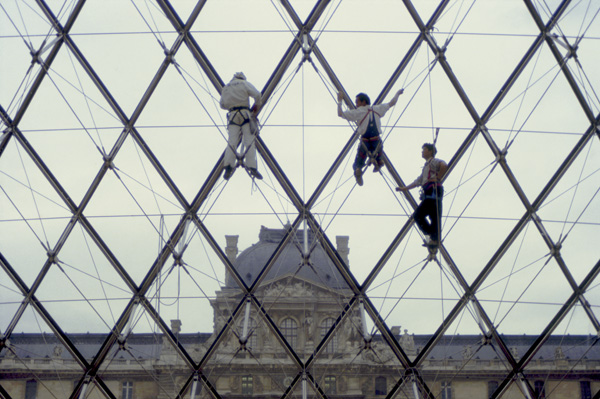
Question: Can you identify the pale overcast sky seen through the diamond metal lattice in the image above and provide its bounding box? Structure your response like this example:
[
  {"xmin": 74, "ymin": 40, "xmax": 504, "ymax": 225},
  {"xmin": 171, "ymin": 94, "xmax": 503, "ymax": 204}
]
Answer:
[{"xmin": 0, "ymin": 0, "xmax": 600, "ymax": 354}]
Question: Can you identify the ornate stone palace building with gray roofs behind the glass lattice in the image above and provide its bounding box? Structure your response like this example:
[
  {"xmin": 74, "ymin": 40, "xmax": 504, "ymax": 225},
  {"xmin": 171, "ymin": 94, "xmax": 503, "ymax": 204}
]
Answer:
[{"xmin": 0, "ymin": 227, "xmax": 600, "ymax": 399}]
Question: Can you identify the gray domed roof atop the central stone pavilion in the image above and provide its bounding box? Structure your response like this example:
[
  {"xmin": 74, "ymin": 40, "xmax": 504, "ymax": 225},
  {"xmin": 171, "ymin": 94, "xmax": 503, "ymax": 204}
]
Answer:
[{"xmin": 225, "ymin": 226, "xmax": 348, "ymax": 289}]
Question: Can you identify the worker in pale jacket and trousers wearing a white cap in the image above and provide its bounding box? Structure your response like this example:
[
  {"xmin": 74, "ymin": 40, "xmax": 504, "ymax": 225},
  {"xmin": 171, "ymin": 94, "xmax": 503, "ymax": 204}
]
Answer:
[{"xmin": 220, "ymin": 72, "xmax": 262, "ymax": 180}]
